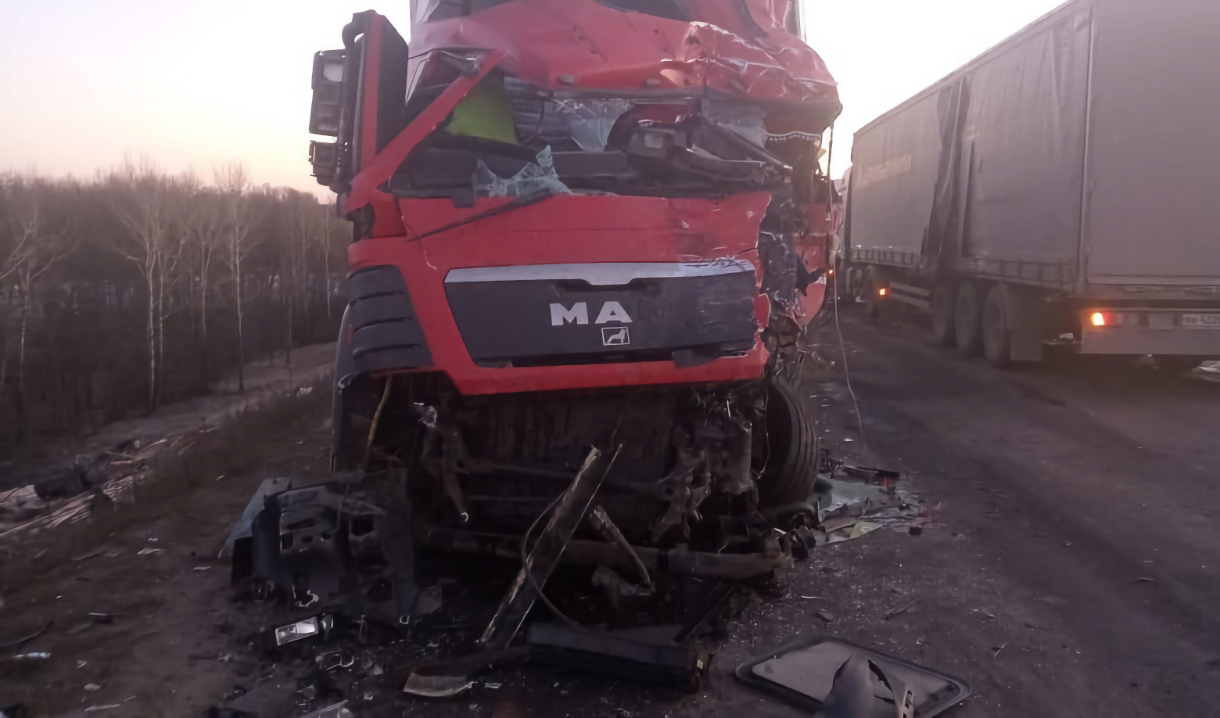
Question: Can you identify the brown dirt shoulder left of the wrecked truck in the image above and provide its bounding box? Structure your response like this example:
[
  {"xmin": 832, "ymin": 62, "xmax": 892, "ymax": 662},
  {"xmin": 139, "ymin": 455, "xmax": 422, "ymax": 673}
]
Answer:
[{"xmin": 0, "ymin": 390, "xmax": 329, "ymax": 717}]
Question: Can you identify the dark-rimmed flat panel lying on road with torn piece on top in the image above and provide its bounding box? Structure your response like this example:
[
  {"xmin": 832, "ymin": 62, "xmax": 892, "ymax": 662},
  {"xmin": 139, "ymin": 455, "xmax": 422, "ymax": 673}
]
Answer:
[{"xmin": 736, "ymin": 636, "xmax": 970, "ymax": 718}]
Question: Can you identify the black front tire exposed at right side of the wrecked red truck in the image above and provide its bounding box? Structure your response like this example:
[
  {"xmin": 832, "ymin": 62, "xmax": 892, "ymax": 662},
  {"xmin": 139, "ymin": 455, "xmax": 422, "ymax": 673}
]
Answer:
[{"xmin": 759, "ymin": 379, "xmax": 817, "ymax": 508}]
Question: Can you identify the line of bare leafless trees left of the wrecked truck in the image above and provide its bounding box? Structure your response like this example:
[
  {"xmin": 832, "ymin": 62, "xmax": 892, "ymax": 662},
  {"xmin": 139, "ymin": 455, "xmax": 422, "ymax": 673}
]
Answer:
[{"xmin": 0, "ymin": 163, "xmax": 350, "ymax": 455}]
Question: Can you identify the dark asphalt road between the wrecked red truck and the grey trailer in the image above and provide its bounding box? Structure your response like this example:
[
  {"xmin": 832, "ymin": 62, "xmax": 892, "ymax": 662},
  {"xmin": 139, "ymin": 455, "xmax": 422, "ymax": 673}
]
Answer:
[{"xmin": 726, "ymin": 309, "xmax": 1220, "ymax": 717}]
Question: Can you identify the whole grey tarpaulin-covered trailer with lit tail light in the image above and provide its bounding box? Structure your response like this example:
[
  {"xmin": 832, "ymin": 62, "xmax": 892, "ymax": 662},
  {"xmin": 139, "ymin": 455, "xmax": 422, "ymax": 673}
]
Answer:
[{"xmin": 845, "ymin": 0, "xmax": 1220, "ymax": 364}]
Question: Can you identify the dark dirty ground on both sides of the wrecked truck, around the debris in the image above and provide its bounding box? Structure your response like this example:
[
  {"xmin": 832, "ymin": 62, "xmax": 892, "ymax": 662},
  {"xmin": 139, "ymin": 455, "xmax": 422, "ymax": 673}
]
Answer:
[{"xmin": 0, "ymin": 313, "xmax": 1220, "ymax": 718}]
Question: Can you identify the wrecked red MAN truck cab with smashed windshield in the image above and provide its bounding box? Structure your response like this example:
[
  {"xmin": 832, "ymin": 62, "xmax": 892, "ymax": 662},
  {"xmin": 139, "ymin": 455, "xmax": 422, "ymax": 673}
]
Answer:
[{"xmin": 302, "ymin": 0, "xmax": 841, "ymax": 609}]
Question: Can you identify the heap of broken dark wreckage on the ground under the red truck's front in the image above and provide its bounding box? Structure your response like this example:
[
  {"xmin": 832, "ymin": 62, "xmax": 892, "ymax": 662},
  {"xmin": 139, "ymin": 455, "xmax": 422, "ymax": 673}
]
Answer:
[{"xmin": 219, "ymin": 450, "xmax": 927, "ymax": 716}]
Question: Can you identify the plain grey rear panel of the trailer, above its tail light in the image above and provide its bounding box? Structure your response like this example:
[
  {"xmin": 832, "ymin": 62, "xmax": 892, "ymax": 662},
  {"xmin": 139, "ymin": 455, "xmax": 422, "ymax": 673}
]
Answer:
[{"xmin": 1082, "ymin": 0, "xmax": 1220, "ymax": 293}]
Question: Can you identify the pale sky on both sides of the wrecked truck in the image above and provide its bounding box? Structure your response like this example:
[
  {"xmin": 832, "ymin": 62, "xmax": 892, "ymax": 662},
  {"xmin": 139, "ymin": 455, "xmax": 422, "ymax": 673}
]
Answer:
[{"xmin": 0, "ymin": 0, "xmax": 1060, "ymax": 191}]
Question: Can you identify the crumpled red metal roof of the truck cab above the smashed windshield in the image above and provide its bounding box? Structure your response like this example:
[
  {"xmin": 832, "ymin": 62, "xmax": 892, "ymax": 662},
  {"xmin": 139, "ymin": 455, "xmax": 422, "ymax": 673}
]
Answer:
[{"xmin": 411, "ymin": 0, "xmax": 838, "ymax": 104}]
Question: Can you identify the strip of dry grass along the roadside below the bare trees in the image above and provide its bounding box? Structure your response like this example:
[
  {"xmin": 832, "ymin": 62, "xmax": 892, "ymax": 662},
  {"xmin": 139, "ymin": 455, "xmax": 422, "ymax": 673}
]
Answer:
[{"xmin": 0, "ymin": 377, "xmax": 331, "ymax": 590}]
